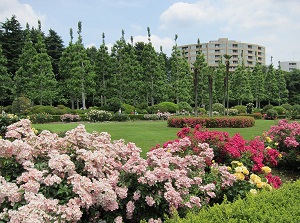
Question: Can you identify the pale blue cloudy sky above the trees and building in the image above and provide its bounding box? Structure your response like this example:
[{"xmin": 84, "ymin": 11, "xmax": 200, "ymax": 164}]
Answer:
[{"xmin": 0, "ymin": 0, "xmax": 300, "ymax": 67}]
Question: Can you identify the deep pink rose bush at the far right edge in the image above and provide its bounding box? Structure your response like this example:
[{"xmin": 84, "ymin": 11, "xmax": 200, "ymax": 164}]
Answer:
[{"xmin": 264, "ymin": 119, "xmax": 300, "ymax": 169}]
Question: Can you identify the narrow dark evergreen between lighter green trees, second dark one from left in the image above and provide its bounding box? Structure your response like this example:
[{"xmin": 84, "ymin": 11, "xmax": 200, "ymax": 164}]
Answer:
[{"xmin": 45, "ymin": 29, "xmax": 64, "ymax": 80}]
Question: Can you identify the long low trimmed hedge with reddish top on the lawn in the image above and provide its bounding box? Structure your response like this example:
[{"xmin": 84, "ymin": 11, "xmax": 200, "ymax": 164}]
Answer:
[{"xmin": 168, "ymin": 116, "xmax": 255, "ymax": 128}]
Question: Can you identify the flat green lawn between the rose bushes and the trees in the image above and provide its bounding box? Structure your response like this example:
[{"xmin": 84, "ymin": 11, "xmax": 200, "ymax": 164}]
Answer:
[{"xmin": 33, "ymin": 120, "xmax": 277, "ymax": 157}]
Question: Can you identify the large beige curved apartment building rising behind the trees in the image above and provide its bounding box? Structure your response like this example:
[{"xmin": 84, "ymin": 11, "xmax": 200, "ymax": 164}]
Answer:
[{"xmin": 178, "ymin": 38, "xmax": 266, "ymax": 71}]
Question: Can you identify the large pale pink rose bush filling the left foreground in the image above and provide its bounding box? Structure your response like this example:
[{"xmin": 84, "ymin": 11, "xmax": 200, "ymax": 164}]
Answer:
[{"xmin": 0, "ymin": 119, "xmax": 237, "ymax": 223}]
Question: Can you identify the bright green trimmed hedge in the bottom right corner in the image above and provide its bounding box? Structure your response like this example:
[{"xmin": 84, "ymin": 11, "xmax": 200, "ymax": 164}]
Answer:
[{"xmin": 165, "ymin": 180, "xmax": 300, "ymax": 223}]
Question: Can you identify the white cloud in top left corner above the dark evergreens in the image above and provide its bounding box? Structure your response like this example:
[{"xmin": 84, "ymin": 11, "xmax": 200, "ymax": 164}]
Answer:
[{"xmin": 0, "ymin": 0, "xmax": 46, "ymax": 28}]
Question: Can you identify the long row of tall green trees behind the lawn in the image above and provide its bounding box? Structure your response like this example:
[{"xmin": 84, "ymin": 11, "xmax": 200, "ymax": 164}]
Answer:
[{"xmin": 0, "ymin": 15, "xmax": 300, "ymax": 109}]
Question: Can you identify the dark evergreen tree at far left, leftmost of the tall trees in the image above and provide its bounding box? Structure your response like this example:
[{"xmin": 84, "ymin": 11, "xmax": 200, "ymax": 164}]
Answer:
[{"xmin": 0, "ymin": 15, "xmax": 24, "ymax": 77}]
